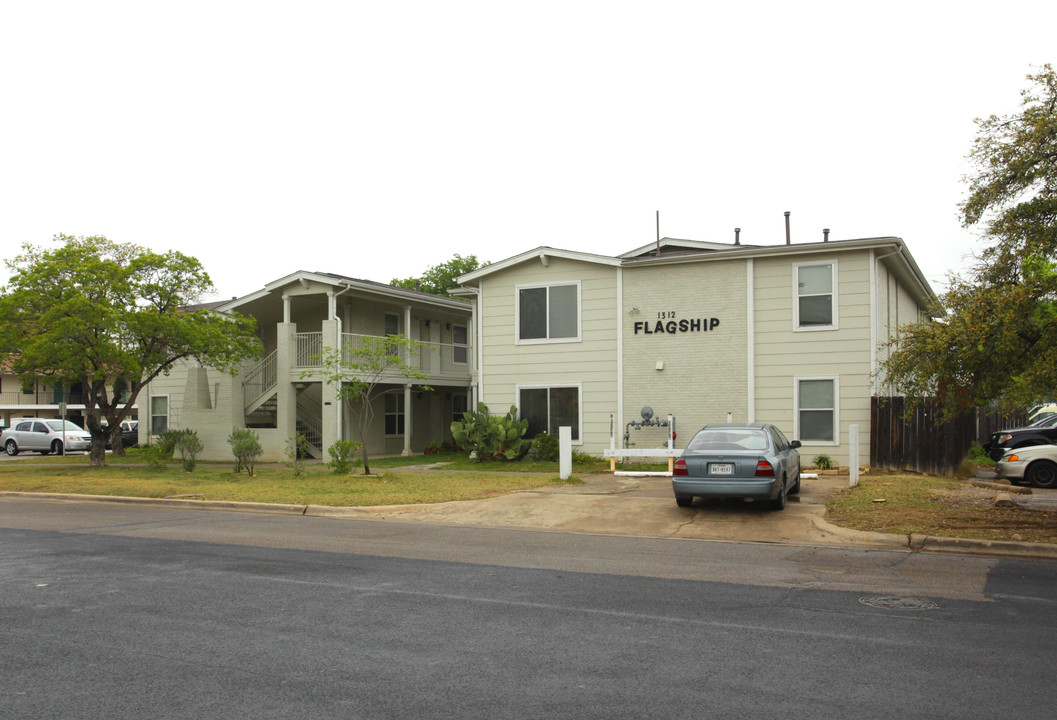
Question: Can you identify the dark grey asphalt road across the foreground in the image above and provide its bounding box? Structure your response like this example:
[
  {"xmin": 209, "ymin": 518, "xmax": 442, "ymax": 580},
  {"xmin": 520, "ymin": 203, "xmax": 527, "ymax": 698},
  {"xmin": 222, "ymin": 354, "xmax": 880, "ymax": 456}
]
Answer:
[{"xmin": 0, "ymin": 499, "xmax": 1057, "ymax": 720}]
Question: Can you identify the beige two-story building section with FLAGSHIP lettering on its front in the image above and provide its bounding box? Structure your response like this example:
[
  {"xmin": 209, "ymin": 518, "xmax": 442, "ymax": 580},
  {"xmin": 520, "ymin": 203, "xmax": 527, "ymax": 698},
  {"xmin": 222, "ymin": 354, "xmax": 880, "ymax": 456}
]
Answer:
[{"xmin": 459, "ymin": 237, "xmax": 935, "ymax": 464}]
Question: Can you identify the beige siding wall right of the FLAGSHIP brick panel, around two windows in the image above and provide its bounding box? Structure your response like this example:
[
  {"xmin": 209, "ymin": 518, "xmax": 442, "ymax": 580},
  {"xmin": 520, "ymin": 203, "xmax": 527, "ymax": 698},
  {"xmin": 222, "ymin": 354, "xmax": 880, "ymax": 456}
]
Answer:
[{"xmin": 754, "ymin": 251, "xmax": 873, "ymax": 464}]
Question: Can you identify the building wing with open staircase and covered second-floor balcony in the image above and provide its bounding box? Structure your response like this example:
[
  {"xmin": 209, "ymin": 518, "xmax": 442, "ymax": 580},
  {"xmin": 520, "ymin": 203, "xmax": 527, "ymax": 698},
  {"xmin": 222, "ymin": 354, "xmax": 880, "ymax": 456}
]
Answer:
[{"xmin": 151, "ymin": 271, "xmax": 472, "ymax": 461}]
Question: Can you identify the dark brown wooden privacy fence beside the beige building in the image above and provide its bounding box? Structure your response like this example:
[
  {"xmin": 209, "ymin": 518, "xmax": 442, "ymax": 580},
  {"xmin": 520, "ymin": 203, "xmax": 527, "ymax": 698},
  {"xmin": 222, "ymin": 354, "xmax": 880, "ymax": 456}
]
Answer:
[{"xmin": 870, "ymin": 396, "xmax": 1027, "ymax": 475}]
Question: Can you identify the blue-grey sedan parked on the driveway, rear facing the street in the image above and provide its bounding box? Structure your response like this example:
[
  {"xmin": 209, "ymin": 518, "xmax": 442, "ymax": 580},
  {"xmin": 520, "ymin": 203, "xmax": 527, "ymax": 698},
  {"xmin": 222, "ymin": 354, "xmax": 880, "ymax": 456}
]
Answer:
[{"xmin": 671, "ymin": 423, "xmax": 800, "ymax": 510}]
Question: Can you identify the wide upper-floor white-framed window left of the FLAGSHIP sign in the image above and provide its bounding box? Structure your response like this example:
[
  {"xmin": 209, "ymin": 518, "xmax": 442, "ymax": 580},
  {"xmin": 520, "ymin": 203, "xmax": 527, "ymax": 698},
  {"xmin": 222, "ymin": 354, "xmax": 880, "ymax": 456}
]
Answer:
[{"xmin": 514, "ymin": 280, "xmax": 580, "ymax": 345}]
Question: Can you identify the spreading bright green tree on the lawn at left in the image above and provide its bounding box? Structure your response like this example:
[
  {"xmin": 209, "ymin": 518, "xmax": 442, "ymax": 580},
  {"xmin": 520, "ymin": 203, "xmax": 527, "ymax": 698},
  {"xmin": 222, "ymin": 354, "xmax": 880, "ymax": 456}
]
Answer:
[{"xmin": 0, "ymin": 235, "xmax": 260, "ymax": 465}]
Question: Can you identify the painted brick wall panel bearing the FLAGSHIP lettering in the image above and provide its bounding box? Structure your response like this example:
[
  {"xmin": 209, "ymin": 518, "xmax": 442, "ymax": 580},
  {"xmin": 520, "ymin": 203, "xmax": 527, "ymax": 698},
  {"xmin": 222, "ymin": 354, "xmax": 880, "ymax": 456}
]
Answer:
[{"xmin": 619, "ymin": 260, "xmax": 748, "ymax": 447}]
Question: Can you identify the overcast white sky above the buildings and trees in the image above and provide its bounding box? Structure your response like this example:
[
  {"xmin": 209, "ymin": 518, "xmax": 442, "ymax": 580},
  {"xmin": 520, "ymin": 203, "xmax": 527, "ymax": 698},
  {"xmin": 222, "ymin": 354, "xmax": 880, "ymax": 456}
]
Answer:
[{"xmin": 0, "ymin": 0, "xmax": 1057, "ymax": 297}]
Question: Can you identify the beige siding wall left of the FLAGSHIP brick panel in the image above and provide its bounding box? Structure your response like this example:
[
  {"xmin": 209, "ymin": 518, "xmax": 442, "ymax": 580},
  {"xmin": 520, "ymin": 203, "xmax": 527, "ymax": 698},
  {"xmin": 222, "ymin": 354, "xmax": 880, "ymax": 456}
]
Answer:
[{"xmin": 480, "ymin": 257, "xmax": 617, "ymax": 454}]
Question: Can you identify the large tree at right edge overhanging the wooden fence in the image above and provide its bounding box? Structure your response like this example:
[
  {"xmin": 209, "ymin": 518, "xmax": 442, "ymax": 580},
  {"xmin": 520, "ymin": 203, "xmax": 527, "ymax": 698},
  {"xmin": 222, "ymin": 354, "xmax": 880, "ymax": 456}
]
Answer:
[{"xmin": 882, "ymin": 64, "xmax": 1057, "ymax": 417}]
